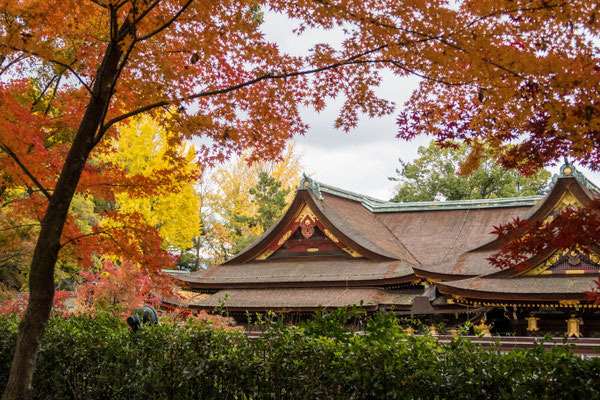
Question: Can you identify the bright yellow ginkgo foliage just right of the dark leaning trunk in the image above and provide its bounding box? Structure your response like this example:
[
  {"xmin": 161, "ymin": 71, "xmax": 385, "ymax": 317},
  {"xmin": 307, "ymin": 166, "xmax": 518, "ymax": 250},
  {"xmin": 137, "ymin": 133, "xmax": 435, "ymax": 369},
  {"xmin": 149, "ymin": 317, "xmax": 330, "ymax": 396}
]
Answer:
[{"xmin": 102, "ymin": 116, "xmax": 200, "ymax": 250}]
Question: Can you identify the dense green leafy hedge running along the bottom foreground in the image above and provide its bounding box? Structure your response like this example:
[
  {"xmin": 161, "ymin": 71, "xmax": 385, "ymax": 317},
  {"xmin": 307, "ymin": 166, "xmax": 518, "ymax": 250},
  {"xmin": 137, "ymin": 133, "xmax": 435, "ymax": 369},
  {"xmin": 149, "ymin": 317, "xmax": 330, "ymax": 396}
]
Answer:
[{"xmin": 0, "ymin": 313, "xmax": 600, "ymax": 400}]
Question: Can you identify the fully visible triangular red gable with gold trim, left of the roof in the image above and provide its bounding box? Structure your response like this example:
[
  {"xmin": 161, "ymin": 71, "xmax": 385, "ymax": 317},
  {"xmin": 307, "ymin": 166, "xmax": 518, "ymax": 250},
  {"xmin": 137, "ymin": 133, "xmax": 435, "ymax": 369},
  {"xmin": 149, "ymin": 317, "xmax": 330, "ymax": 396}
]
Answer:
[{"xmin": 254, "ymin": 203, "xmax": 363, "ymax": 260}]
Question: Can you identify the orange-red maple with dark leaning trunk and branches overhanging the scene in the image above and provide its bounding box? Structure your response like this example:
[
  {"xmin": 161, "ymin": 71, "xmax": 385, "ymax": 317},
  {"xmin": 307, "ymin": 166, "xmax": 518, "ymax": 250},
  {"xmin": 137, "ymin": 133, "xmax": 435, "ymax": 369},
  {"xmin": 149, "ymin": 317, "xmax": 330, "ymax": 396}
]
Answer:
[{"xmin": 0, "ymin": 0, "xmax": 600, "ymax": 400}]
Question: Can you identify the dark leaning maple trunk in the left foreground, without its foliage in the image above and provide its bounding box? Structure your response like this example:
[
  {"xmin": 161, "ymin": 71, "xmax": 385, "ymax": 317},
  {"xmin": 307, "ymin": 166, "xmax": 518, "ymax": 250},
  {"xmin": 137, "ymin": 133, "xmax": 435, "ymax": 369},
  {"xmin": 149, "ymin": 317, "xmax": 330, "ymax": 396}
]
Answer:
[{"xmin": 2, "ymin": 27, "xmax": 126, "ymax": 400}]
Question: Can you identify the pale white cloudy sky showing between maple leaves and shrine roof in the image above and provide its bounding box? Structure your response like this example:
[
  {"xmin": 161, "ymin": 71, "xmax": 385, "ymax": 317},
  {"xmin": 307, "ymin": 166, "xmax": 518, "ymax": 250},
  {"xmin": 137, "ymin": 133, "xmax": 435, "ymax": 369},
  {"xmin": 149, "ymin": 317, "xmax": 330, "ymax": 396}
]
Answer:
[{"xmin": 262, "ymin": 12, "xmax": 600, "ymax": 200}]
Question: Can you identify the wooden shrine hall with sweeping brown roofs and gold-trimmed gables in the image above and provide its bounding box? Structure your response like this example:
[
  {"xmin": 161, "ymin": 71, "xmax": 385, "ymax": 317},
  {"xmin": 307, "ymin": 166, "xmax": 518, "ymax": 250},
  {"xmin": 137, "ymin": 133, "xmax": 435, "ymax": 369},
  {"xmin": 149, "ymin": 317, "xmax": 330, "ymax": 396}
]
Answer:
[{"xmin": 169, "ymin": 164, "xmax": 600, "ymax": 337}]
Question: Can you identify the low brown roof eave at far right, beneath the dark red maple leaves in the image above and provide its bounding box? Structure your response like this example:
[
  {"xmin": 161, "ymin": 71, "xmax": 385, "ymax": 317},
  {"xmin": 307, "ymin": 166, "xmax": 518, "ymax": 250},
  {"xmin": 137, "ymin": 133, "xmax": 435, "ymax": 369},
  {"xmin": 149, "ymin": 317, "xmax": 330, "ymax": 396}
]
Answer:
[{"xmin": 435, "ymin": 276, "xmax": 598, "ymax": 301}]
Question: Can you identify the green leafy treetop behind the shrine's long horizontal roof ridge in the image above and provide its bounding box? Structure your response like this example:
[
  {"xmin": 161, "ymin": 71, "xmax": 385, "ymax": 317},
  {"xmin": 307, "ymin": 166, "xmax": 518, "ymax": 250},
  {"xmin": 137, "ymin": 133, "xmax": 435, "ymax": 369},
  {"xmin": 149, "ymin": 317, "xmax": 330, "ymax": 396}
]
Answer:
[{"xmin": 388, "ymin": 142, "xmax": 550, "ymax": 201}]
